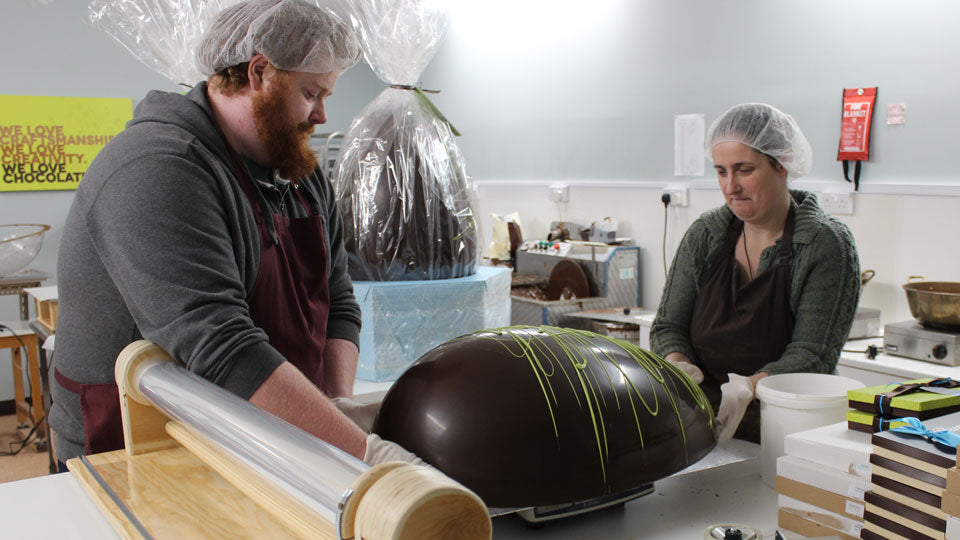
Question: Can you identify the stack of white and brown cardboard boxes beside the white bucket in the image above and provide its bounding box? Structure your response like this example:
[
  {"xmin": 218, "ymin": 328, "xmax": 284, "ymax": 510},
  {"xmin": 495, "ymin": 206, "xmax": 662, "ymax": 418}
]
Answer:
[{"xmin": 776, "ymin": 422, "xmax": 870, "ymax": 540}]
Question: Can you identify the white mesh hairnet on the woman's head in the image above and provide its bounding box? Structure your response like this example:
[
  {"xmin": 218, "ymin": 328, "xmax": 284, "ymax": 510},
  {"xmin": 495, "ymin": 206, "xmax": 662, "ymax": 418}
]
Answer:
[{"xmin": 707, "ymin": 103, "xmax": 813, "ymax": 178}]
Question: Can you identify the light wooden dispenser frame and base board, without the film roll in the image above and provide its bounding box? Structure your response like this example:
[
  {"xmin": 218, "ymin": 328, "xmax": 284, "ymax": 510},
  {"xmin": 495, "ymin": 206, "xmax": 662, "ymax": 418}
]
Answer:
[{"xmin": 67, "ymin": 341, "xmax": 492, "ymax": 540}]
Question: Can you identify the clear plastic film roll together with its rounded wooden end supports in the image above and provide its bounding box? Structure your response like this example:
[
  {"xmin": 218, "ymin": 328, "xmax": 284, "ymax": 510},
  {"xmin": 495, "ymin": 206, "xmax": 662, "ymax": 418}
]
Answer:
[{"xmin": 116, "ymin": 341, "xmax": 492, "ymax": 540}]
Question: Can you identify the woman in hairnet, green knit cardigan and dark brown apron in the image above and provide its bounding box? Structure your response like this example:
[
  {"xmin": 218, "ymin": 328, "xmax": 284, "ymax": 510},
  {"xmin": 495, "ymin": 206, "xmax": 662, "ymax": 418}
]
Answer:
[{"xmin": 650, "ymin": 103, "xmax": 860, "ymax": 442}]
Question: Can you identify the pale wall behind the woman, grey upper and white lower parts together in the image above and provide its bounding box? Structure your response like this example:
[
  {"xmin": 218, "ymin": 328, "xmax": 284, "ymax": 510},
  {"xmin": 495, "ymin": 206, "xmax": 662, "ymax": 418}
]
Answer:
[{"xmin": 423, "ymin": 0, "xmax": 960, "ymax": 330}]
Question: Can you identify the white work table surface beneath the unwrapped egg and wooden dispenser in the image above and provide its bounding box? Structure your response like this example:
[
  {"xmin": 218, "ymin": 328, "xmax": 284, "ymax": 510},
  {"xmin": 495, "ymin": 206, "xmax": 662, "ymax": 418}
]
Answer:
[{"xmin": 0, "ymin": 441, "xmax": 776, "ymax": 540}]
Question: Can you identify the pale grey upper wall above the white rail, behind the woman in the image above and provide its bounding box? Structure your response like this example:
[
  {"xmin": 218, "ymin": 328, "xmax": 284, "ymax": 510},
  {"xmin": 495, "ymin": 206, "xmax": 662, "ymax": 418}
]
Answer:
[{"xmin": 423, "ymin": 0, "xmax": 960, "ymax": 182}]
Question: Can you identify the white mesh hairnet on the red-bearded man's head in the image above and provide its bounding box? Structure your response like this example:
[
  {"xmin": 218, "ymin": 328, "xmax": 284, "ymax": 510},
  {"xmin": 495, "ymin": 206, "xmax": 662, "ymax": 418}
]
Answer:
[{"xmin": 197, "ymin": 0, "xmax": 362, "ymax": 77}]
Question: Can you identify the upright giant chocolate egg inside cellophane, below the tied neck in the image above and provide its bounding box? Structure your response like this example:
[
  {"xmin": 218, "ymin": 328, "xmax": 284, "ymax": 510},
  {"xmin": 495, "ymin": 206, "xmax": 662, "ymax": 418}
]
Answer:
[{"xmin": 334, "ymin": 88, "xmax": 478, "ymax": 281}]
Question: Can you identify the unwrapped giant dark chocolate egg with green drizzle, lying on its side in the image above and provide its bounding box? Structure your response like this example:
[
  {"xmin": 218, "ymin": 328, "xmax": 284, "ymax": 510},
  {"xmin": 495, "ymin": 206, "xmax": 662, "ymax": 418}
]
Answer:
[{"xmin": 374, "ymin": 326, "xmax": 716, "ymax": 507}]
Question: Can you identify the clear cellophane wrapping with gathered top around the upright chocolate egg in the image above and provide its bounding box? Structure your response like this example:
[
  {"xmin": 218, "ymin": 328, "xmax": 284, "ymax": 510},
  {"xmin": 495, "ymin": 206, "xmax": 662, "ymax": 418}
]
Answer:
[{"xmin": 334, "ymin": 0, "xmax": 479, "ymax": 281}]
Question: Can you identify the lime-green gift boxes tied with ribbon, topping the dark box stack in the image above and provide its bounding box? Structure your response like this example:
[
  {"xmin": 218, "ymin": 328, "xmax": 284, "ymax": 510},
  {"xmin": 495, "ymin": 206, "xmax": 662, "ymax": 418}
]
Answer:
[{"xmin": 847, "ymin": 378, "xmax": 960, "ymax": 433}]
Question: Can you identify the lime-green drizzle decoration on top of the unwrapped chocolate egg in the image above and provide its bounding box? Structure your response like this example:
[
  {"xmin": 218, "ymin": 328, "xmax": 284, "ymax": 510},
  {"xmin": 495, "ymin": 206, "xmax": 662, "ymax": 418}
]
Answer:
[{"xmin": 458, "ymin": 326, "xmax": 713, "ymax": 482}]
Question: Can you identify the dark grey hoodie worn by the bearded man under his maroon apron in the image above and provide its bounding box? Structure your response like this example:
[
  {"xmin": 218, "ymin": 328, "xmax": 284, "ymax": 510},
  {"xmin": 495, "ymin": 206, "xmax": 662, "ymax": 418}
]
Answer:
[{"xmin": 50, "ymin": 83, "xmax": 360, "ymax": 461}]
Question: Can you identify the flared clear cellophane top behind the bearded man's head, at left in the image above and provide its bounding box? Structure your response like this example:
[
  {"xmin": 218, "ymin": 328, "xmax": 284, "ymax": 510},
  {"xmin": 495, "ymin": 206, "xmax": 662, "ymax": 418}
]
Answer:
[{"xmin": 87, "ymin": 0, "xmax": 238, "ymax": 85}]
